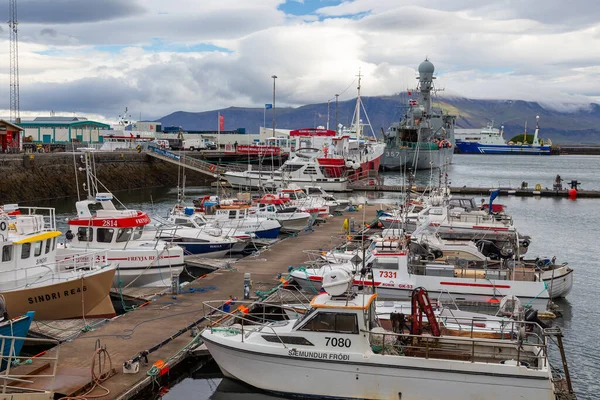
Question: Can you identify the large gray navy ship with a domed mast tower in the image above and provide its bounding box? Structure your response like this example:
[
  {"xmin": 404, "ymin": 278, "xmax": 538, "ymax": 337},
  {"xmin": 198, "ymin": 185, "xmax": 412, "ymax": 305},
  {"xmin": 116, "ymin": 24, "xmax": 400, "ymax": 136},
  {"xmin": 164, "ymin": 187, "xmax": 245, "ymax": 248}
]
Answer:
[{"xmin": 381, "ymin": 59, "xmax": 456, "ymax": 170}]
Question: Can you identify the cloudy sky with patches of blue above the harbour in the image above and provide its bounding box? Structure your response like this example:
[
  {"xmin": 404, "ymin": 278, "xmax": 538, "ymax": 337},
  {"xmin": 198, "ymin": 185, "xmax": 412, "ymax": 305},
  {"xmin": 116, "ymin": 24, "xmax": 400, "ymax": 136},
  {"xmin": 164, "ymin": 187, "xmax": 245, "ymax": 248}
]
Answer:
[{"xmin": 0, "ymin": 0, "xmax": 600, "ymax": 121}]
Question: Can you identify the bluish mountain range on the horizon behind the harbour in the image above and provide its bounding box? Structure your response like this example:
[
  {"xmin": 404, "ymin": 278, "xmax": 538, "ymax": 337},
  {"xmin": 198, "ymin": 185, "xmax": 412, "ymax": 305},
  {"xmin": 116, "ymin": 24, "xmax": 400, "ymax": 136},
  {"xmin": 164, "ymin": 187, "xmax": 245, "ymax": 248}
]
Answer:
[{"xmin": 157, "ymin": 93, "xmax": 600, "ymax": 144}]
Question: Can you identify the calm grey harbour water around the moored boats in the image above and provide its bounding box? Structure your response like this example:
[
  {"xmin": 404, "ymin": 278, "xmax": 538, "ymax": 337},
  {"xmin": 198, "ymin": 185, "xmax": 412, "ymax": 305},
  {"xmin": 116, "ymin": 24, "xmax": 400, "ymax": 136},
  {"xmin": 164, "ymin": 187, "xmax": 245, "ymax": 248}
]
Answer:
[{"xmin": 38, "ymin": 155, "xmax": 600, "ymax": 400}]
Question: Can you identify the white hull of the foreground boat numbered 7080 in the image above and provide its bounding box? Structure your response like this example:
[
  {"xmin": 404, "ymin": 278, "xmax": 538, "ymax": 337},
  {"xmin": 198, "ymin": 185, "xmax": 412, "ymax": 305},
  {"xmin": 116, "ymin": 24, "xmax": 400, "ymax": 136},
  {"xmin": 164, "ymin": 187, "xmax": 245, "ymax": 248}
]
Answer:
[{"xmin": 203, "ymin": 334, "xmax": 554, "ymax": 400}]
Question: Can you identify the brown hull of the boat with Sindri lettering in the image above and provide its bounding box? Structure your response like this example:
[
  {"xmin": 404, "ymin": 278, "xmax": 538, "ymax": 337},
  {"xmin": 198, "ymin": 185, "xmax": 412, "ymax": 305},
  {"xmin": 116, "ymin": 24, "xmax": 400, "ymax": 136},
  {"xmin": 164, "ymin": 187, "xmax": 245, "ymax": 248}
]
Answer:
[{"xmin": 2, "ymin": 268, "xmax": 115, "ymax": 320}]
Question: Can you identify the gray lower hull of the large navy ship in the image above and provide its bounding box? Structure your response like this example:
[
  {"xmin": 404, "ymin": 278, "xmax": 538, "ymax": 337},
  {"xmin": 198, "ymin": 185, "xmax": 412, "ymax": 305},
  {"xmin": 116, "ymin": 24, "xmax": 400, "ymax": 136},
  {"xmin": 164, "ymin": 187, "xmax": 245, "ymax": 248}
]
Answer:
[{"xmin": 381, "ymin": 146, "xmax": 454, "ymax": 170}]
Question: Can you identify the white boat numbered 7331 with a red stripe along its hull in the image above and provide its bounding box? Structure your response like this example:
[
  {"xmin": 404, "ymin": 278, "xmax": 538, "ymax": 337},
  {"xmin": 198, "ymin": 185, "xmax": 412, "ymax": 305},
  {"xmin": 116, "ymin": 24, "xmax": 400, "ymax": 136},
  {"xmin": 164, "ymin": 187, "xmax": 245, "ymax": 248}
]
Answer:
[{"xmin": 291, "ymin": 234, "xmax": 573, "ymax": 311}]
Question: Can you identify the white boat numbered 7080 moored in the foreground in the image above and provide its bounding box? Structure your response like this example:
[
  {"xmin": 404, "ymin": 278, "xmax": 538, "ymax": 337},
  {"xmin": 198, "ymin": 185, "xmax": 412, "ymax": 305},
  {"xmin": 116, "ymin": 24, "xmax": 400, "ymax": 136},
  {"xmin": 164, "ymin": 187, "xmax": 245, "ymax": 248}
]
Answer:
[{"xmin": 201, "ymin": 271, "xmax": 555, "ymax": 400}]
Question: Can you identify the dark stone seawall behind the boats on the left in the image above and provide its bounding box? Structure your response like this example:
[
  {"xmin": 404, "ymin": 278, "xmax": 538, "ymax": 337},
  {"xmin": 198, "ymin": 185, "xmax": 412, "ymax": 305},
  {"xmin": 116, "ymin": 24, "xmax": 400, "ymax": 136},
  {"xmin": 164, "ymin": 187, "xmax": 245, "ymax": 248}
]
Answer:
[{"xmin": 0, "ymin": 152, "xmax": 214, "ymax": 204}]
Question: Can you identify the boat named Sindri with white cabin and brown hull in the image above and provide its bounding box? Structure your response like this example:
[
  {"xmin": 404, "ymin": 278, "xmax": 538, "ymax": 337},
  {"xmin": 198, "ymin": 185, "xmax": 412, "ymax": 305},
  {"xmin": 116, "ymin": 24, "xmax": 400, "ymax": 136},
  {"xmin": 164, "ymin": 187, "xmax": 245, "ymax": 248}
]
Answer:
[{"xmin": 0, "ymin": 204, "xmax": 116, "ymax": 320}]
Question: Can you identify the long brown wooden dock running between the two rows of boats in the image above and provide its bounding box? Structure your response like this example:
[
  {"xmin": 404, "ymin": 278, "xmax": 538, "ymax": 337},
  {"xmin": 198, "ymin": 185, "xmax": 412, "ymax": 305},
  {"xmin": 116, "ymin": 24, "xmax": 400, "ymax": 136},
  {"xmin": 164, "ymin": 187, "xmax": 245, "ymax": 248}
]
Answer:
[{"xmin": 11, "ymin": 206, "xmax": 376, "ymax": 399}]
